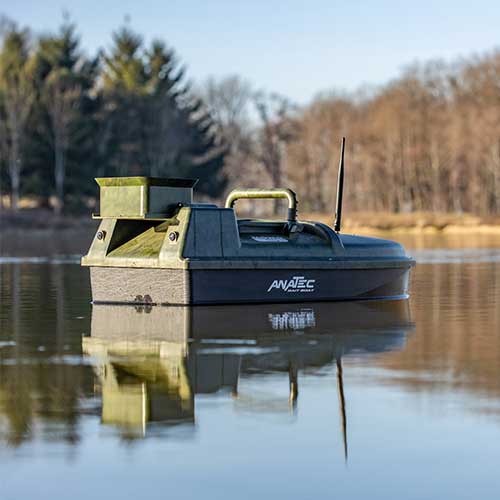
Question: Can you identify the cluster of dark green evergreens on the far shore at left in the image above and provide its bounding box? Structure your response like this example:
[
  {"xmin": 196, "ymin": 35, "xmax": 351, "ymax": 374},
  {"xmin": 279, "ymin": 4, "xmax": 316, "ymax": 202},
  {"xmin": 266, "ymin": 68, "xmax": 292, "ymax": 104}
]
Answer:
[{"xmin": 0, "ymin": 19, "xmax": 226, "ymax": 213}]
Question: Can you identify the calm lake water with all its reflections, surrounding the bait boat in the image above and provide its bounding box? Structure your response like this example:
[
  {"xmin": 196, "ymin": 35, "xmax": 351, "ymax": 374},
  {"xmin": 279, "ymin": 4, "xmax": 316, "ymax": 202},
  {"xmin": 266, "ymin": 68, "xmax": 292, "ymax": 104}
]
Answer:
[{"xmin": 0, "ymin": 237, "xmax": 500, "ymax": 500}]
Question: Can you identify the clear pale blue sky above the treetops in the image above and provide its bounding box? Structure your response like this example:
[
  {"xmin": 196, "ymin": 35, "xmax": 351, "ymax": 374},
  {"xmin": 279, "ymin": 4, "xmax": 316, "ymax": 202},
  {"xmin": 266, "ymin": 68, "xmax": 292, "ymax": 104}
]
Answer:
[{"xmin": 0, "ymin": 0, "xmax": 500, "ymax": 103}]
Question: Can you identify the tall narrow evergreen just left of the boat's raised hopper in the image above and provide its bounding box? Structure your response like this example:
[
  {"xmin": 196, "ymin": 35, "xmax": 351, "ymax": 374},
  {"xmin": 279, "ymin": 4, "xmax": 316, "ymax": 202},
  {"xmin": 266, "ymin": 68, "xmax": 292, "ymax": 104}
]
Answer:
[{"xmin": 31, "ymin": 19, "xmax": 98, "ymax": 213}]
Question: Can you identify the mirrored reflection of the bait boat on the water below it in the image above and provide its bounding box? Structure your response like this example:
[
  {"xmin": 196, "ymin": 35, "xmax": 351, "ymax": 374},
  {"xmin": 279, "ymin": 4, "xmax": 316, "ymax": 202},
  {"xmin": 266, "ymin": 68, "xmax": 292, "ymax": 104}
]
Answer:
[{"xmin": 83, "ymin": 300, "xmax": 413, "ymax": 452}]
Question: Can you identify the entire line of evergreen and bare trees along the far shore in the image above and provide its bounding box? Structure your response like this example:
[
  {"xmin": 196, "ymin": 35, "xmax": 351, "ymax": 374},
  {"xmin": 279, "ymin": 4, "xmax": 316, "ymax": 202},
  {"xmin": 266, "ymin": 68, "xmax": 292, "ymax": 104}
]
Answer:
[{"xmin": 0, "ymin": 15, "xmax": 500, "ymax": 215}]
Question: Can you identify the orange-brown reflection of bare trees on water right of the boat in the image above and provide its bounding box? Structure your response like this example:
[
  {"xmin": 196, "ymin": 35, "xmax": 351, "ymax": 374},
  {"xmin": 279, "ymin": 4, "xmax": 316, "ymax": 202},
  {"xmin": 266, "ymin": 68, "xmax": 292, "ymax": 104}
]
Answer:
[{"xmin": 383, "ymin": 262, "xmax": 500, "ymax": 398}]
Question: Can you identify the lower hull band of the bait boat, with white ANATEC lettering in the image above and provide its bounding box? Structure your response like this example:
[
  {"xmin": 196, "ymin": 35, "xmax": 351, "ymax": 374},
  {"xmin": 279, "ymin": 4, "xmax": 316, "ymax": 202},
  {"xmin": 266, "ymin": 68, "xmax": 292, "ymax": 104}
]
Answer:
[{"xmin": 91, "ymin": 263, "xmax": 411, "ymax": 305}]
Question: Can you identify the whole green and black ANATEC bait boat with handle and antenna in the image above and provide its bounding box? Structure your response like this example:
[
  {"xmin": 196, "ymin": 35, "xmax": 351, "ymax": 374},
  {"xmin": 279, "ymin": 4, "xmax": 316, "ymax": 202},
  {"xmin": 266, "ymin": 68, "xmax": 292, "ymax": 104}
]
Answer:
[{"xmin": 82, "ymin": 137, "xmax": 415, "ymax": 305}]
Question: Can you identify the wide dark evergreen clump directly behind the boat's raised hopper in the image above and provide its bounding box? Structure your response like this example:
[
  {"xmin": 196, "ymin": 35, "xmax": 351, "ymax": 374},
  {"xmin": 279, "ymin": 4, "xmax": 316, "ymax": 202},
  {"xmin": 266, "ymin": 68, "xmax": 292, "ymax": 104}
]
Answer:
[{"xmin": 100, "ymin": 27, "xmax": 225, "ymax": 196}]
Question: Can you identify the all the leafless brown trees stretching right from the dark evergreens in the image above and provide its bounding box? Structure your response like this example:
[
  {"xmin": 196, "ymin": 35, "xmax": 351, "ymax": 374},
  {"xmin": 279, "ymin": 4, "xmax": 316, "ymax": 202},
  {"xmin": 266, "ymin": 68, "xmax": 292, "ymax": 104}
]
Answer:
[{"xmin": 208, "ymin": 57, "xmax": 500, "ymax": 215}]
